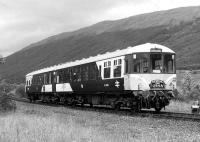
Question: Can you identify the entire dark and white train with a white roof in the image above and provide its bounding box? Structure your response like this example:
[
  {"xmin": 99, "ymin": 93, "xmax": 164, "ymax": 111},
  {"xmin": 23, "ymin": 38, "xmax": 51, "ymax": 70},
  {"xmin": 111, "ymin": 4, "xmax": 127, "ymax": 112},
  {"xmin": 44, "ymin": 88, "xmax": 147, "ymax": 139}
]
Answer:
[{"xmin": 25, "ymin": 43, "xmax": 176, "ymax": 111}]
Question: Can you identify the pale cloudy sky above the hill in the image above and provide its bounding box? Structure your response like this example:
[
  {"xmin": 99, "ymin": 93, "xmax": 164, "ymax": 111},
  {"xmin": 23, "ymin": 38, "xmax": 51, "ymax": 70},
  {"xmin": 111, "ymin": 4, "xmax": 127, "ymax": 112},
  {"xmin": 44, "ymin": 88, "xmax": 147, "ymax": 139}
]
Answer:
[{"xmin": 0, "ymin": 0, "xmax": 200, "ymax": 56}]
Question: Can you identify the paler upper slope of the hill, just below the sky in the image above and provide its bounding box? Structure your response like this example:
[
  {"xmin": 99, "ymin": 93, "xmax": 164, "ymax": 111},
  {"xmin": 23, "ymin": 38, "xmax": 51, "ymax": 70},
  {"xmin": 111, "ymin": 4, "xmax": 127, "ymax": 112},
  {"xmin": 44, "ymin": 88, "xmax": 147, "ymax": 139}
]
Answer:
[{"xmin": 25, "ymin": 7, "xmax": 200, "ymax": 47}]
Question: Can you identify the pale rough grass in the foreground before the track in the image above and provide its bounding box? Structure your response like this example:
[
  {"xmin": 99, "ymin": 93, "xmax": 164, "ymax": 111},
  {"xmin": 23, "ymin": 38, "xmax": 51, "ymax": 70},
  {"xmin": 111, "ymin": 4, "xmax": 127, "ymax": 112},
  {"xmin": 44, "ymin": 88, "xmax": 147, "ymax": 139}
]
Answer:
[{"xmin": 0, "ymin": 103, "xmax": 200, "ymax": 142}]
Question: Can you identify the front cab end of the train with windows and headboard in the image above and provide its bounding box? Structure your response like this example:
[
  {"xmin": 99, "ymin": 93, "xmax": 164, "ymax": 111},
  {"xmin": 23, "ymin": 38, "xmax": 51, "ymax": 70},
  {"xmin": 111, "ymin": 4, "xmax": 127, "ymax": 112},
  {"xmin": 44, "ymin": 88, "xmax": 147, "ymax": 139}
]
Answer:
[{"xmin": 124, "ymin": 48, "xmax": 176, "ymax": 111}]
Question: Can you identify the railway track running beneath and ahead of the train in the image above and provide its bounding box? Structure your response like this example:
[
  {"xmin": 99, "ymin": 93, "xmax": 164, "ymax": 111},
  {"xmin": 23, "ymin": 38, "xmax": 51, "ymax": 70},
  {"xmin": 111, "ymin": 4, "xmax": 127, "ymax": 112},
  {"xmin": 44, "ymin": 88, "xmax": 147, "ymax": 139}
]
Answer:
[{"xmin": 9, "ymin": 96, "xmax": 200, "ymax": 121}]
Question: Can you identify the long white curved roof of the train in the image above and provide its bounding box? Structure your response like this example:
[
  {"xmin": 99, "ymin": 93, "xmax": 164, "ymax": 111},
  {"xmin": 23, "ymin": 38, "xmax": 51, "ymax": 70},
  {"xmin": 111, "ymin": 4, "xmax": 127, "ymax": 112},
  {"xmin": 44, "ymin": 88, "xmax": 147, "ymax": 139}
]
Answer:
[{"xmin": 26, "ymin": 43, "xmax": 175, "ymax": 76}]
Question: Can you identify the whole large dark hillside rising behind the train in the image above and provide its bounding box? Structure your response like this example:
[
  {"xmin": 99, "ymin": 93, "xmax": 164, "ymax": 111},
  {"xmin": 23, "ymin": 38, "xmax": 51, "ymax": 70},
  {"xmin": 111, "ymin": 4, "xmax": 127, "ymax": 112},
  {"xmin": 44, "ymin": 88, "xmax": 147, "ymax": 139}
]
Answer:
[{"xmin": 0, "ymin": 7, "xmax": 200, "ymax": 82}]
